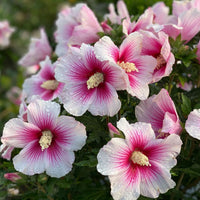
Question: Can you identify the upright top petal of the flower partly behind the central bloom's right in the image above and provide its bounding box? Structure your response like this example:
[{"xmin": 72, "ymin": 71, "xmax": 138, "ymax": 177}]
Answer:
[{"xmin": 119, "ymin": 32, "xmax": 143, "ymax": 62}]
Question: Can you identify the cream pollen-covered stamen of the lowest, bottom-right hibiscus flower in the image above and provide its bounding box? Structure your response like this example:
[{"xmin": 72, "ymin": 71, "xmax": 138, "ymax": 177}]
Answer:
[{"xmin": 131, "ymin": 151, "xmax": 151, "ymax": 166}]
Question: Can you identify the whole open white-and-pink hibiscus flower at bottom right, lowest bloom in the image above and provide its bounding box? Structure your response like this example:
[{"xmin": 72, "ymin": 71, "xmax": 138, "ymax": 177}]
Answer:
[{"xmin": 97, "ymin": 118, "xmax": 182, "ymax": 200}]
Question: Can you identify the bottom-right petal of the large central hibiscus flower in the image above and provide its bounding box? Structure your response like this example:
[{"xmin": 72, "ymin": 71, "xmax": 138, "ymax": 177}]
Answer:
[{"xmin": 88, "ymin": 83, "xmax": 121, "ymax": 116}]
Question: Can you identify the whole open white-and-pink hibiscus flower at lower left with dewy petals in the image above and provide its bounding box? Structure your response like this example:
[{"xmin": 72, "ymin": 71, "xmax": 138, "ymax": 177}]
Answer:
[{"xmin": 1, "ymin": 100, "xmax": 86, "ymax": 178}]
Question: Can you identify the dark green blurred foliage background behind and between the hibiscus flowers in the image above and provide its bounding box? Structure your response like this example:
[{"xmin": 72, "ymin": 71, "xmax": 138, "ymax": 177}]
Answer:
[{"xmin": 0, "ymin": 0, "xmax": 200, "ymax": 200}]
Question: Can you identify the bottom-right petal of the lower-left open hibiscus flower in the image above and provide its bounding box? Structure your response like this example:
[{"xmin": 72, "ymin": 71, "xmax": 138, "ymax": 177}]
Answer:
[{"xmin": 44, "ymin": 142, "xmax": 75, "ymax": 178}]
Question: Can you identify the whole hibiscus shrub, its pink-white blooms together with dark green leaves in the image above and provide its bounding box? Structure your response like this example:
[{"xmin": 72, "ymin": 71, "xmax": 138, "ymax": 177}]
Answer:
[{"xmin": 0, "ymin": 0, "xmax": 200, "ymax": 200}]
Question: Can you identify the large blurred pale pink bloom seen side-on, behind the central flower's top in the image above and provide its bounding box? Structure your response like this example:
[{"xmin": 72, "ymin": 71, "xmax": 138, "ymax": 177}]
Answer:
[{"xmin": 55, "ymin": 3, "xmax": 103, "ymax": 56}]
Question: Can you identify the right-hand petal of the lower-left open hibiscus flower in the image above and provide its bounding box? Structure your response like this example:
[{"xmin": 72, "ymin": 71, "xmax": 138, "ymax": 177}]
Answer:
[{"xmin": 53, "ymin": 116, "xmax": 87, "ymax": 151}]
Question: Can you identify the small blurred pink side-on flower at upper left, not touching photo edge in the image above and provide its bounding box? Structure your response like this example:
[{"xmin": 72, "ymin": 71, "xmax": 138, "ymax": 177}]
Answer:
[{"xmin": 18, "ymin": 29, "xmax": 52, "ymax": 67}]
